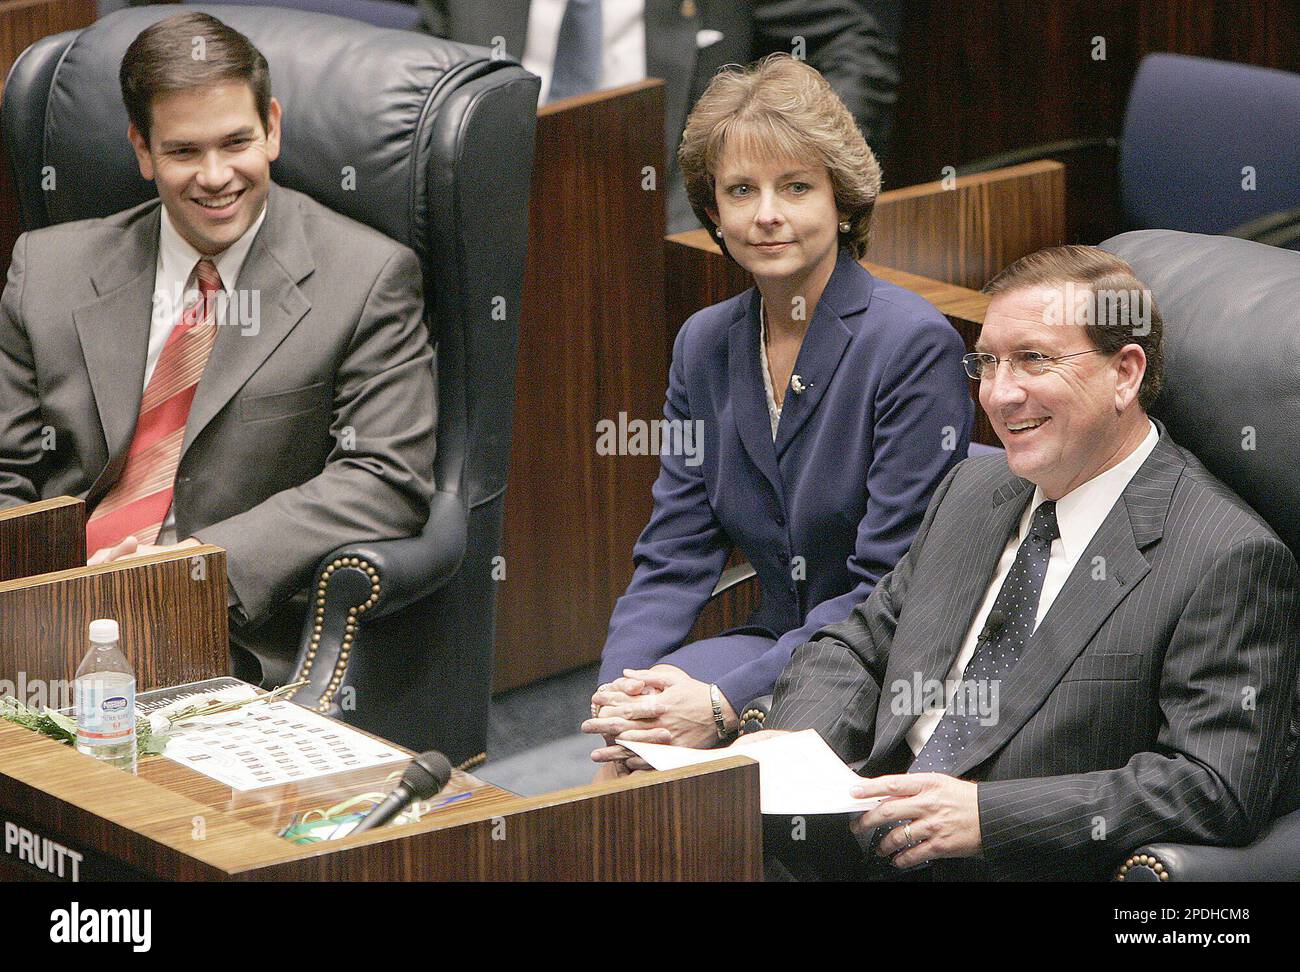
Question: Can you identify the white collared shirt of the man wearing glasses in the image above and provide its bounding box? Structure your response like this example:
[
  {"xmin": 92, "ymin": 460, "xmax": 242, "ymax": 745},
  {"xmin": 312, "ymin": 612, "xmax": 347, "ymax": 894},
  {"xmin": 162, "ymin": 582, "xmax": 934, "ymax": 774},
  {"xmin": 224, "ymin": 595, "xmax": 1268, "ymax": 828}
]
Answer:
[{"xmin": 907, "ymin": 421, "xmax": 1160, "ymax": 754}]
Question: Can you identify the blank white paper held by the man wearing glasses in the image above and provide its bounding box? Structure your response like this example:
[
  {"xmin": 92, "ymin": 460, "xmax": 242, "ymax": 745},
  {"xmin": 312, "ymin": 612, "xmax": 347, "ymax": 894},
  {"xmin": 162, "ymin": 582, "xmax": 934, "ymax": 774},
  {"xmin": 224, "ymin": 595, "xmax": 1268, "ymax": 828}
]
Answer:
[{"xmin": 618, "ymin": 729, "xmax": 880, "ymax": 816}]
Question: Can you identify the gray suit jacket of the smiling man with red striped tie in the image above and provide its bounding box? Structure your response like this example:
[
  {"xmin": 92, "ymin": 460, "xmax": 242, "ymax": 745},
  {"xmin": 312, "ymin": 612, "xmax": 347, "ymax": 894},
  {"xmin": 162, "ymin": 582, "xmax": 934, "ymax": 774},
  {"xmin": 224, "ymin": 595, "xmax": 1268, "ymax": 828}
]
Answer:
[{"xmin": 0, "ymin": 185, "xmax": 436, "ymax": 619}]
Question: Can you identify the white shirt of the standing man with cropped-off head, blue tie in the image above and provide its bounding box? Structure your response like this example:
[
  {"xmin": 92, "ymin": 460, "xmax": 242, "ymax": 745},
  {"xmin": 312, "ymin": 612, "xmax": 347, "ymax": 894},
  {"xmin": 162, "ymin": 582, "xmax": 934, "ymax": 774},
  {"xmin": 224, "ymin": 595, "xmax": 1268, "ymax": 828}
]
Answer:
[{"xmin": 521, "ymin": 0, "xmax": 646, "ymax": 104}]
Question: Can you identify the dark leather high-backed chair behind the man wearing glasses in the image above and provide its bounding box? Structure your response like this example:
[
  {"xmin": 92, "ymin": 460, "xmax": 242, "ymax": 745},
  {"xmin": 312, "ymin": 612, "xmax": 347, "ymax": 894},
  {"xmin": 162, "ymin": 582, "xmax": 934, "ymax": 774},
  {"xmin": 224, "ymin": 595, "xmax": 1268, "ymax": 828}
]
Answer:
[{"xmin": 1101, "ymin": 230, "xmax": 1300, "ymax": 881}]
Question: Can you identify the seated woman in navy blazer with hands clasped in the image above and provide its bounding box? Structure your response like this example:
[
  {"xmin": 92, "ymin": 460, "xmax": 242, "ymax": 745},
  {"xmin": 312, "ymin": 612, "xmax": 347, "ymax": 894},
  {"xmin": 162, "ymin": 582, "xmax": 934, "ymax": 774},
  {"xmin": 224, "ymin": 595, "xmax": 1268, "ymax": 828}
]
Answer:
[{"xmin": 582, "ymin": 55, "xmax": 974, "ymax": 772}]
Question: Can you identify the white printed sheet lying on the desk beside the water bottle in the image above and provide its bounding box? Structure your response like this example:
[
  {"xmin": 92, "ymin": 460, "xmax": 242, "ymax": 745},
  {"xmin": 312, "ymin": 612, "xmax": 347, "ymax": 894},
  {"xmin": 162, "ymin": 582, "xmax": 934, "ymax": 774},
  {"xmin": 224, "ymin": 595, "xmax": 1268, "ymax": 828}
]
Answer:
[{"xmin": 159, "ymin": 689, "xmax": 410, "ymax": 790}]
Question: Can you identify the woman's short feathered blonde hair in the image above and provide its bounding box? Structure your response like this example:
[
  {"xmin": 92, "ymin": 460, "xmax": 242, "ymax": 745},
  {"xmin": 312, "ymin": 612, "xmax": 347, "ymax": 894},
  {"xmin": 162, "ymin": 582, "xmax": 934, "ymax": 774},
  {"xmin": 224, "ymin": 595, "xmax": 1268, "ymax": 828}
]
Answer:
[{"xmin": 677, "ymin": 53, "xmax": 880, "ymax": 260}]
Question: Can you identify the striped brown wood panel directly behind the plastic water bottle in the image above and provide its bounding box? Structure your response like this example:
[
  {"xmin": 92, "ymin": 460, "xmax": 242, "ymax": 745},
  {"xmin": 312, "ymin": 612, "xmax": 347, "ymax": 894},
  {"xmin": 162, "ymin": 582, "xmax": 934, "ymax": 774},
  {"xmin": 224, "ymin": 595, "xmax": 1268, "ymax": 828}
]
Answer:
[{"xmin": 0, "ymin": 546, "xmax": 230, "ymax": 690}]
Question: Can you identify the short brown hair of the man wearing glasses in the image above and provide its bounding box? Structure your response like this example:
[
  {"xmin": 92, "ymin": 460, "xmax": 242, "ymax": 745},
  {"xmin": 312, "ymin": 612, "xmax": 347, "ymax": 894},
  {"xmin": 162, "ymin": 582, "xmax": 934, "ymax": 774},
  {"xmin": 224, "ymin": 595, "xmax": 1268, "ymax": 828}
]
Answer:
[{"xmin": 983, "ymin": 246, "xmax": 1165, "ymax": 411}]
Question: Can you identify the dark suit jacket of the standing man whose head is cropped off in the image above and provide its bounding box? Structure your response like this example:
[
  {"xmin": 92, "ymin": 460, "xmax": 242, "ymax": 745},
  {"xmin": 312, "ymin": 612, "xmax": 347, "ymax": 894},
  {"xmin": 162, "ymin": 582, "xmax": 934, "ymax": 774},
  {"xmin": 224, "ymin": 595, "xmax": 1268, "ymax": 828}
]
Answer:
[{"xmin": 419, "ymin": 0, "xmax": 898, "ymax": 233}]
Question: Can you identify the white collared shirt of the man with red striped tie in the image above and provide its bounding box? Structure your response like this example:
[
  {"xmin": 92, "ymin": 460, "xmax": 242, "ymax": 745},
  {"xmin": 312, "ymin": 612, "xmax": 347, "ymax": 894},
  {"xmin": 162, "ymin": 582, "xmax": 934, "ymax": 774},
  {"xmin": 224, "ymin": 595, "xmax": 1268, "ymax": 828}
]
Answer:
[{"xmin": 144, "ymin": 203, "xmax": 267, "ymax": 544}]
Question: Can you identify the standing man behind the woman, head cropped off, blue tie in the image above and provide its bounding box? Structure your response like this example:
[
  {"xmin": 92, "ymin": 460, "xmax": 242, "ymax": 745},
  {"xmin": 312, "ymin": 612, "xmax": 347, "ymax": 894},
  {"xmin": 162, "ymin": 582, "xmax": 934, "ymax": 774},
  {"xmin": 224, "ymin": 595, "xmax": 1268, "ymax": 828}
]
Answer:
[{"xmin": 419, "ymin": 0, "xmax": 900, "ymax": 233}]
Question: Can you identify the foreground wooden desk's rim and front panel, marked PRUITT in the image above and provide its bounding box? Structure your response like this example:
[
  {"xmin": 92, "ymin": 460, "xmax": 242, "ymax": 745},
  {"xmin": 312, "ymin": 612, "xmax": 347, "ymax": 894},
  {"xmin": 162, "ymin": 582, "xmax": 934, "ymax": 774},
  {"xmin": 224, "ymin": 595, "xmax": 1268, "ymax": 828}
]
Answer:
[{"xmin": 0, "ymin": 723, "xmax": 762, "ymax": 881}]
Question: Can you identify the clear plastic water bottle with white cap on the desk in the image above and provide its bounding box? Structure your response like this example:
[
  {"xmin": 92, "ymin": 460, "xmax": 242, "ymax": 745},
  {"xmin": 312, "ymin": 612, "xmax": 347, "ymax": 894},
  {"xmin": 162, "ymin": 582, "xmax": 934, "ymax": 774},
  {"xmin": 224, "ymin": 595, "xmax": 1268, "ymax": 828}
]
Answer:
[{"xmin": 73, "ymin": 619, "xmax": 135, "ymax": 773}]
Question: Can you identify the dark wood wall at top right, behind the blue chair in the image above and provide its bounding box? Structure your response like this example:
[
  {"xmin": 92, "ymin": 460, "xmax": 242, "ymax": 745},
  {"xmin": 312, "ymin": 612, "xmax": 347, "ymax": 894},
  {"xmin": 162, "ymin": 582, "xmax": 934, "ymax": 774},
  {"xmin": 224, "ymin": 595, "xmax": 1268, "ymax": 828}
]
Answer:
[{"xmin": 885, "ymin": 0, "xmax": 1300, "ymax": 243}]
